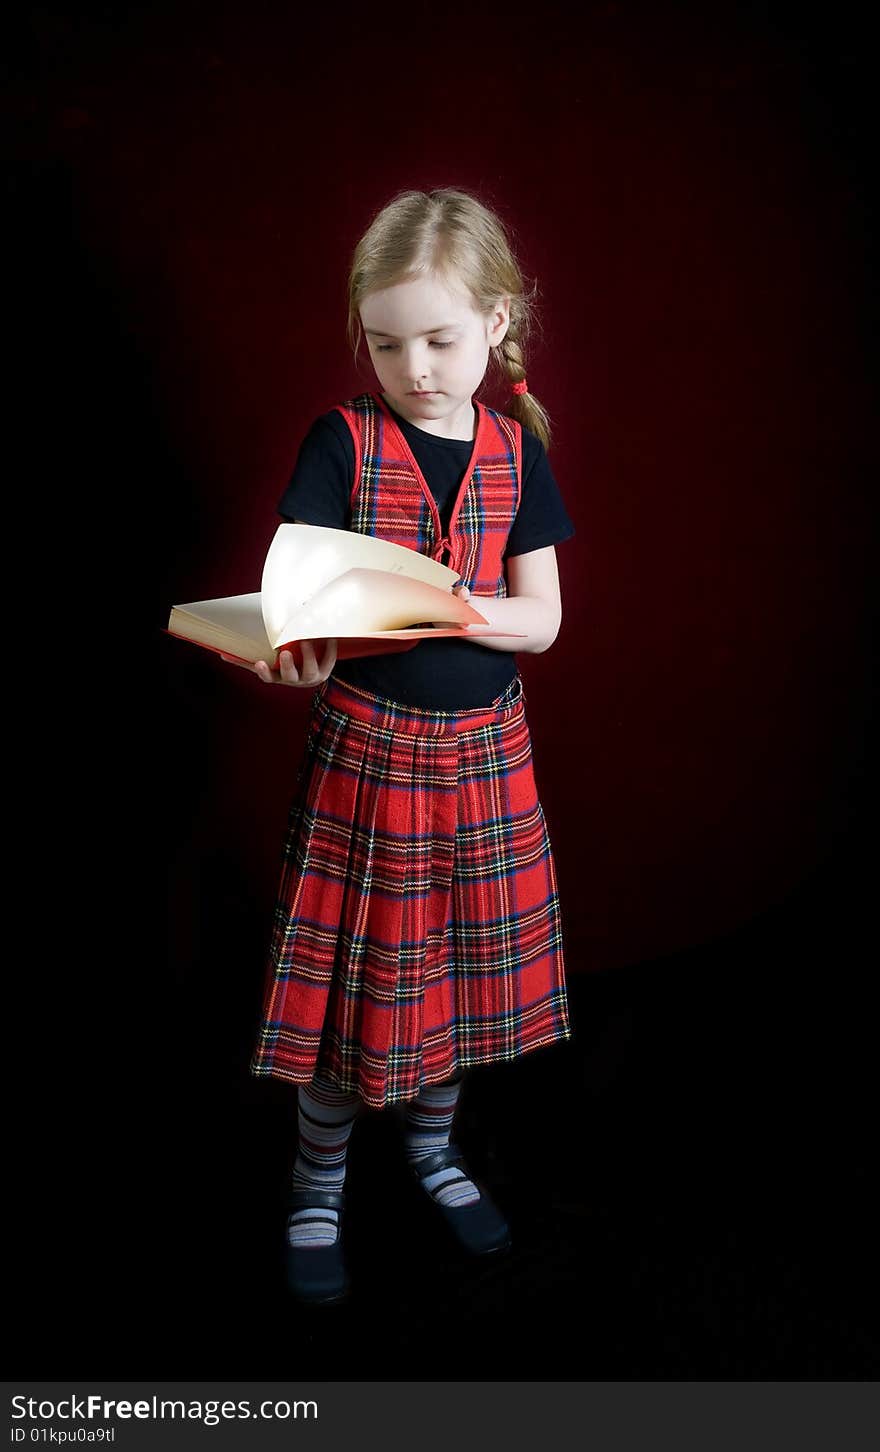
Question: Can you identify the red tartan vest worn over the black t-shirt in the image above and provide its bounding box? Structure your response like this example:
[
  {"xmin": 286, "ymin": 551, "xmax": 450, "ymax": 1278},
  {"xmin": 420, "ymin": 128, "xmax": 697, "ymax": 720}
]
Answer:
[{"xmin": 338, "ymin": 393, "xmax": 521, "ymax": 597}]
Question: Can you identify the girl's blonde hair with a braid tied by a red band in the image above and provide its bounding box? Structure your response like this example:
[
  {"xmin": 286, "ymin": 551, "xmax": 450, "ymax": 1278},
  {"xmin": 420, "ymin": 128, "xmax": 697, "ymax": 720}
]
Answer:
[{"xmin": 347, "ymin": 187, "xmax": 550, "ymax": 447}]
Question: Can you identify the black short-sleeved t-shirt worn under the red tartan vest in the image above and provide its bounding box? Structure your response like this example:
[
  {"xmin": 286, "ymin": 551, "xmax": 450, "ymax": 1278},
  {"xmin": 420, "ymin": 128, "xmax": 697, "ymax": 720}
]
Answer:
[{"xmin": 277, "ymin": 409, "xmax": 575, "ymax": 711}]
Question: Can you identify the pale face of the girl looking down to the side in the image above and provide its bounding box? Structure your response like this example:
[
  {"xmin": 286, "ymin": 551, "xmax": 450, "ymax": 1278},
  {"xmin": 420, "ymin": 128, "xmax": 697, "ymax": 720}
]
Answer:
[{"xmin": 360, "ymin": 274, "xmax": 510, "ymax": 439}]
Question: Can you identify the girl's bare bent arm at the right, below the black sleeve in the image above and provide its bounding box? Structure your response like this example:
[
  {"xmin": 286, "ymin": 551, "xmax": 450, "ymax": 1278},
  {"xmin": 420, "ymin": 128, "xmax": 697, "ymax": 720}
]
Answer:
[{"xmin": 456, "ymin": 545, "xmax": 562, "ymax": 655}]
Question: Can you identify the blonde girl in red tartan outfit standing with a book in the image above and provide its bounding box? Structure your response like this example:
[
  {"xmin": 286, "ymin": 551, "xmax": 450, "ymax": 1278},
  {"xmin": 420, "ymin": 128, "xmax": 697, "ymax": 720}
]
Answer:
[{"xmin": 227, "ymin": 189, "xmax": 574, "ymax": 1301}]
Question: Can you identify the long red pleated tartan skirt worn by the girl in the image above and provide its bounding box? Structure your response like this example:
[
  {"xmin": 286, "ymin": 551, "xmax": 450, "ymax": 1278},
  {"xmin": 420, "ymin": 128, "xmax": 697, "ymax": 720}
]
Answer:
[{"xmin": 250, "ymin": 675, "xmax": 571, "ymax": 1108}]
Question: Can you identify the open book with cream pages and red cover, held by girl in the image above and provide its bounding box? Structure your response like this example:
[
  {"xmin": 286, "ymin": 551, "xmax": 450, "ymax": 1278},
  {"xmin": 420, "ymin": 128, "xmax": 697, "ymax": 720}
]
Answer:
[{"xmin": 167, "ymin": 524, "xmax": 522, "ymax": 666}]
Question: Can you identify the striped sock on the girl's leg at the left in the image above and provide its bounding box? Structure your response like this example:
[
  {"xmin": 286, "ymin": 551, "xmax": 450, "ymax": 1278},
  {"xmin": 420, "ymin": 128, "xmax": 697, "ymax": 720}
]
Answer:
[{"xmin": 288, "ymin": 1076, "xmax": 360, "ymax": 1247}]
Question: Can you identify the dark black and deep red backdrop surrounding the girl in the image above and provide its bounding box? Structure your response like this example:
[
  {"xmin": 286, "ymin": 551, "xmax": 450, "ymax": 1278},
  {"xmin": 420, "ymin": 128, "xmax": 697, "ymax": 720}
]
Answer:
[{"xmin": 4, "ymin": 0, "xmax": 877, "ymax": 1376}]
